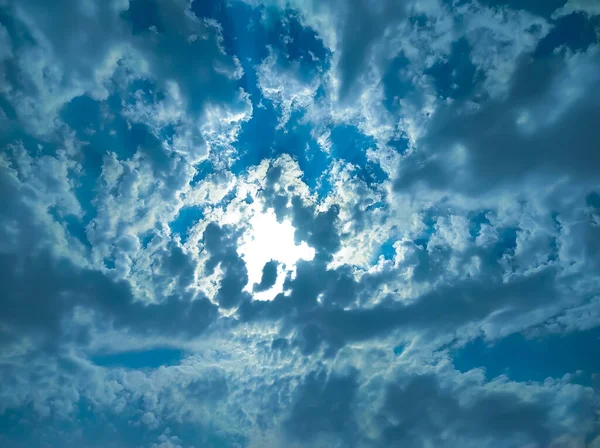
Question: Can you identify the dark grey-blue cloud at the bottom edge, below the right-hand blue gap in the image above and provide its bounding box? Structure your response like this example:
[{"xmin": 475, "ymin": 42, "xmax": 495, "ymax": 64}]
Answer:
[{"xmin": 380, "ymin": 375, "xmax": 555, "ymax": 448}]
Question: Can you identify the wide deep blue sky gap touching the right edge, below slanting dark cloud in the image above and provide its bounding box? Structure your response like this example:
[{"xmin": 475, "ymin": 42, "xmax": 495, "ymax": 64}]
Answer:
[{"xmin": 450, "ymin": 327, "xmax": 600, "ymax": 385}]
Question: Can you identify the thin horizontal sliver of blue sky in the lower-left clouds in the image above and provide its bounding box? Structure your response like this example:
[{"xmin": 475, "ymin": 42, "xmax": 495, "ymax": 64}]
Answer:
[{"xmin": 90, "ymin": 348, "xmax": 185, "ymax": 369}]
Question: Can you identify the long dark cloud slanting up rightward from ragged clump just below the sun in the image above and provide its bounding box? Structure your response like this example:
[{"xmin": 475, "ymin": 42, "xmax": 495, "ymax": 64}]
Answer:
[{"xmin": 239, "ymin": 248, "xmax": 561, "ymax": 355}]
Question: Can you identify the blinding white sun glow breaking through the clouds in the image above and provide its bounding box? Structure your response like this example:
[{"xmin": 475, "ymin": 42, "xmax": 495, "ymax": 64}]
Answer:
[{"xmin": 238, "ymin": 209, "xmax": 315, "ymax": 300}]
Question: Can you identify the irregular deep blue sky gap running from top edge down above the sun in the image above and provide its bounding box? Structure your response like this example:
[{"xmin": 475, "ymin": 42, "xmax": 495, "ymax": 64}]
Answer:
[{"xmin": 192, "ymin": 1, "xmax": 328, "ymax": 192}]
